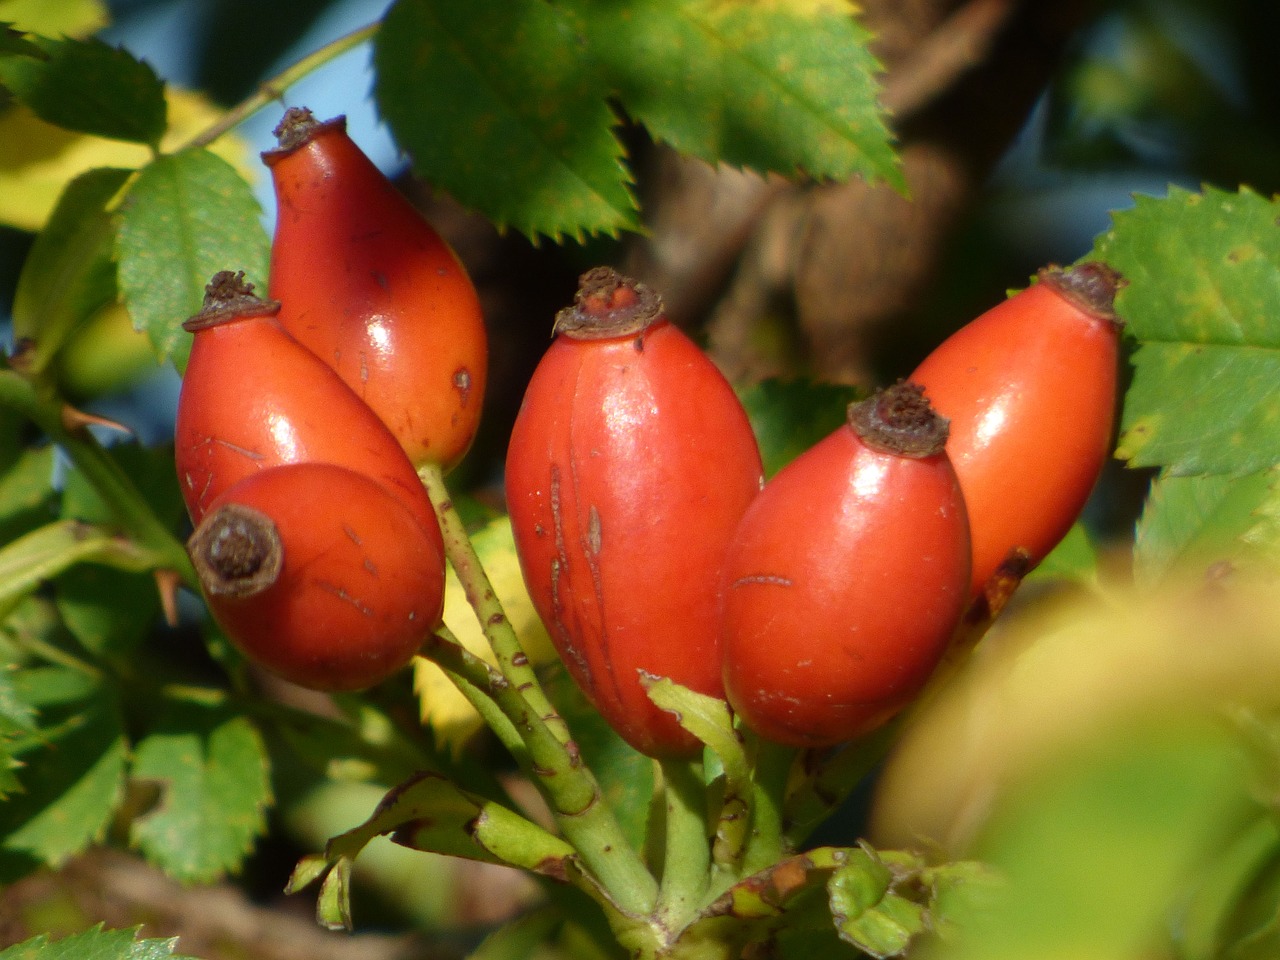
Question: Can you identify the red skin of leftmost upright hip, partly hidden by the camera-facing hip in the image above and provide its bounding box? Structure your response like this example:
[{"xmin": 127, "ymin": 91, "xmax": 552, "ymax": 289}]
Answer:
[{"xmin": 174, "ymin": 308, "xmax": 443, "ymax": 537}]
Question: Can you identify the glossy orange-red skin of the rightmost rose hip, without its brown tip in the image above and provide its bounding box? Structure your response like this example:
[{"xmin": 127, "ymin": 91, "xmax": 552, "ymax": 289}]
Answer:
[{"xmin": 909, "ymin": 282, "xmax": 1120, "ymax": 595}]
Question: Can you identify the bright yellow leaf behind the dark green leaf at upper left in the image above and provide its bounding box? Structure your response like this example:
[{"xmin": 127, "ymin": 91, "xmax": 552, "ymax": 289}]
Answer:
[{"xmin": 0, "ymin": 86, "xmax": 259, "ymax": 232}]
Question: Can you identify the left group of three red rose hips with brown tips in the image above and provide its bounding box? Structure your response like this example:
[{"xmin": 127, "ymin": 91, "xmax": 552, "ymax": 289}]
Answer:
[{"xmin": 175, "ymin": 109, "xmax": 488, "ymax": 690}]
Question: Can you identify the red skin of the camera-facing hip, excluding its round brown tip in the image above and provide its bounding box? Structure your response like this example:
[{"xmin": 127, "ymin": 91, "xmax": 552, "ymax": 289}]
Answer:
[{"xmin": 194, "ymin": 463, "xmax": 444, "ymax": 690}]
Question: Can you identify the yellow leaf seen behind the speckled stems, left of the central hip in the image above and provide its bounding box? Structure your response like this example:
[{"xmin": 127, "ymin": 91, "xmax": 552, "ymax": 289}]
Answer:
[{"xmin": 413, "ymin": 517, "xmax": 556, "ymax": 750}]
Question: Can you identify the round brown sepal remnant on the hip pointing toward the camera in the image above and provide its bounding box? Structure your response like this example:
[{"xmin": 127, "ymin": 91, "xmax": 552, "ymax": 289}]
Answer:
[{"xmin": 187, "ymin": 503, "xmax": 284, "ymax": 596}]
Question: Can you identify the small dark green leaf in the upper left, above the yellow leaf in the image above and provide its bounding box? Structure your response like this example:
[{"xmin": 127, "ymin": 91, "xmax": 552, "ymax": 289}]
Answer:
[{"xmin": 0, "ymin": 37, "xmax": 168, "ymax": 147}]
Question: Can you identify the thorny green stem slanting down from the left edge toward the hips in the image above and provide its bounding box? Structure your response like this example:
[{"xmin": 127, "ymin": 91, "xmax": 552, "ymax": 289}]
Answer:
[{"xmin": 0, "ymin": 370, "xmax": 200, "ymax": 590}]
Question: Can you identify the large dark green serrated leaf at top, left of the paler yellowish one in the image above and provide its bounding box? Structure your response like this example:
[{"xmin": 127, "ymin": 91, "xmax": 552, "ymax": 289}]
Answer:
[{"xmin": 374, "ymin": 0, "xmax": 637, "ymax": 241}]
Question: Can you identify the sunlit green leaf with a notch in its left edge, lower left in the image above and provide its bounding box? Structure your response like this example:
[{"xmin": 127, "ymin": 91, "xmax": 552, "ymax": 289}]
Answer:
[{"xmin": 131, "ymin": 701, "xmax": 271, "ymax": 883}]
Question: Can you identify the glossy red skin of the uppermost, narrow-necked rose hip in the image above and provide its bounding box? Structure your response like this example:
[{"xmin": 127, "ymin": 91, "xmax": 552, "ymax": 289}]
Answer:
[{"xmin": 264, "ymin": 123, "xmax": 489, "ymax": 470}]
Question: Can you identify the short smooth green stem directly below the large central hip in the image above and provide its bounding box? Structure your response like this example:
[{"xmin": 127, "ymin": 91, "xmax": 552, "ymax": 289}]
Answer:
[{"xmin": 658, "ymin": 759, "xmax": 710, "ymax": 929}]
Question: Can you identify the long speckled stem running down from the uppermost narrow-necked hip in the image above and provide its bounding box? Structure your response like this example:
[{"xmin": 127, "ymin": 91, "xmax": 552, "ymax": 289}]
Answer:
[{"xmin": 419, "ymin": 465, "xmax": 658, "ymax": 916}]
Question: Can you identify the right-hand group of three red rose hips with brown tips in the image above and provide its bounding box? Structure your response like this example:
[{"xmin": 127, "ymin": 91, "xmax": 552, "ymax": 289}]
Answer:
[{"xmin": 507, "ymin": 264, "xmax": 1119, "ymax": 755}]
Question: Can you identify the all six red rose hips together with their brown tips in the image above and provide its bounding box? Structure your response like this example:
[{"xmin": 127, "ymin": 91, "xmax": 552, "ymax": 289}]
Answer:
[{"xmin": 177, "ymin": 110, "xmax": 1120, "ymax": 756}]
